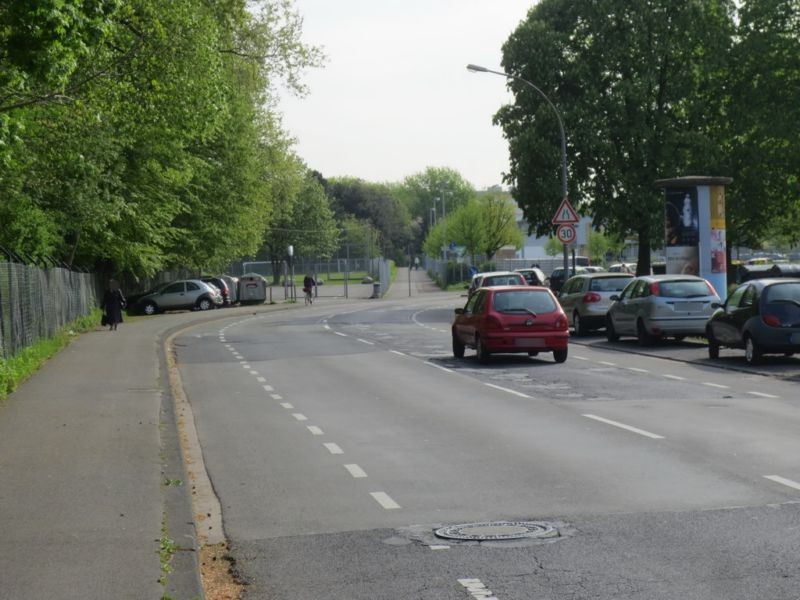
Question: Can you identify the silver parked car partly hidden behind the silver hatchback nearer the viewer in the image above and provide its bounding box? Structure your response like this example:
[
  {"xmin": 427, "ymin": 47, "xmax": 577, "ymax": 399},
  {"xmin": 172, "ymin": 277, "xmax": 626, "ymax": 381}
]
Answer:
[{"xmin": 558, "ymin": 273, "xmax": 633, "ymax": 336}]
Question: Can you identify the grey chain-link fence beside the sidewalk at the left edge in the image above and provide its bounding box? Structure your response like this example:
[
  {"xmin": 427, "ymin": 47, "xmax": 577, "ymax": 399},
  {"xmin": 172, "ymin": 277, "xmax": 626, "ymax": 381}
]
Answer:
[{"xmin": 0, "ymin": 262, "xmax": 98, "ymax": 358}]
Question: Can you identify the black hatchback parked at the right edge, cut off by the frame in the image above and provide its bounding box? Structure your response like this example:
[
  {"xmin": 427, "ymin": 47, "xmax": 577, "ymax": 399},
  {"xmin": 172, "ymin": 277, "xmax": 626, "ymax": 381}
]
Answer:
[{"xmin": 706, "ymin": 278, "xmax": 800, "ymax": 364}]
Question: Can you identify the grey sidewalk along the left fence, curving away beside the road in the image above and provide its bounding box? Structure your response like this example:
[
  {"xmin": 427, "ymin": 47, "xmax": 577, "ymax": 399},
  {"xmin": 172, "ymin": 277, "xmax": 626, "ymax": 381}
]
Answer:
[{"xmin": 0, "ymin": 269, "xmax": 437, "ymax": 600}]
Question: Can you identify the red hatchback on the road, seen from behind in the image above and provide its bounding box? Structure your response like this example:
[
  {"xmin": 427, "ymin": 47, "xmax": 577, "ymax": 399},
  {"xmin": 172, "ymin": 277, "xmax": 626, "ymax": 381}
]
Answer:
[{"xmin": 452, "ymin": 286, "xmax": 569, "ymax": 363}]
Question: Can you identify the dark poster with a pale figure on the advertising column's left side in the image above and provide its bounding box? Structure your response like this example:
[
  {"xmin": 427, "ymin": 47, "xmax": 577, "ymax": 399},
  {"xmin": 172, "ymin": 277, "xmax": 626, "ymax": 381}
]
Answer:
[{"xmin": 664, "ymin": 187, "xmax": 700, "ymax": 275}]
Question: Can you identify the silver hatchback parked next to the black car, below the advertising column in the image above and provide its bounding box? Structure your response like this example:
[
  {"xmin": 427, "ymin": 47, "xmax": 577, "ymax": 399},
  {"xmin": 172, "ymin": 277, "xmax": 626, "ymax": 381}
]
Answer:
[{"xmin": 606, "ymin": 275, "xmax": 720, "ymax": 345}]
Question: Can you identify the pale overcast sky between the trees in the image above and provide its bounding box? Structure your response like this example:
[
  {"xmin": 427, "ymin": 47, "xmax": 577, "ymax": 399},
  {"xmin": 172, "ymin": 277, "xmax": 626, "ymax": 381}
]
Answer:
[{"xmin": 281, "ymin": 0, "xmax": 535, "ymax": 189}]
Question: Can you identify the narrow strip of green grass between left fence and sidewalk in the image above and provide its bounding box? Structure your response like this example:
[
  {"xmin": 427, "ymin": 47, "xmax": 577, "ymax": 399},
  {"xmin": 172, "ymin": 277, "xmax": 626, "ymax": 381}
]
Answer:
[{"xmin": 0, "ymin": 309, "xmax": 101, "ymax": 400}]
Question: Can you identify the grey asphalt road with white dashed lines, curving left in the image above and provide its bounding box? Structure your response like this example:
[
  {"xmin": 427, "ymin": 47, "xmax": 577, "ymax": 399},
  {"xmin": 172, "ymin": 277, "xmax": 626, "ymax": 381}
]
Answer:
[{"xmin": 176, "ymin": 295, "xmax": 800, "ymax": 600}]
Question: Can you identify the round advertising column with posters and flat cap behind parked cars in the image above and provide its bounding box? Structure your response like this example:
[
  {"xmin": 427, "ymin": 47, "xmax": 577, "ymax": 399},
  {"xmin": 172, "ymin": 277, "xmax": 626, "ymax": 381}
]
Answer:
[{"xmin": 656, "ymin": 177, "xmax": 732, "ymax": 300}]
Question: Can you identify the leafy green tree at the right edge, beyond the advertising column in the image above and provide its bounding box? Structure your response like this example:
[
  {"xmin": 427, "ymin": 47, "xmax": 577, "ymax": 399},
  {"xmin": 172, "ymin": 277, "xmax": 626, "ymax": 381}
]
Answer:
[{"xmin": 713, "ymin": 0, "xmax": 800, "ymax": 248}]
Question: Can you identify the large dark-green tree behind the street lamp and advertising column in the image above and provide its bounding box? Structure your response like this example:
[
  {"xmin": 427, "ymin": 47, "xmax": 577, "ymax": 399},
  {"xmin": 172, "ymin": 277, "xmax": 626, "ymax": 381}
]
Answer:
[{"xmin": 495, "ymin": 0, "xmax": 733, "ymax": 272}]
